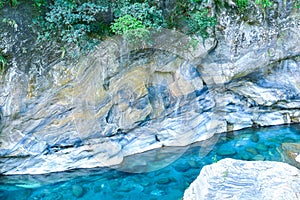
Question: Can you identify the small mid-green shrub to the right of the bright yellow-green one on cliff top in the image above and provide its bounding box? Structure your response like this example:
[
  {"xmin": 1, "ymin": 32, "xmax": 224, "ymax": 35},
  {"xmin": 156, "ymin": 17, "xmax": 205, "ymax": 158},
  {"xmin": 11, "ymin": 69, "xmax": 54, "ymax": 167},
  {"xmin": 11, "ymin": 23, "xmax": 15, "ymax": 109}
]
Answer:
[{"xmin": 188, "ymin": 8, "xmax": 217, "ymax": 40}]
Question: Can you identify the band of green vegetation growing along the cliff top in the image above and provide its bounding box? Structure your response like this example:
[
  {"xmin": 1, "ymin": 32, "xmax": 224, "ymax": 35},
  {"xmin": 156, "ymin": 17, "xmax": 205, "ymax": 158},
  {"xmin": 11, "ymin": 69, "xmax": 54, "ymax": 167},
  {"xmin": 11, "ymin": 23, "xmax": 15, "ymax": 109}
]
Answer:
[{"xmin": 0, "ymin": 0, "xmax": 299, "ymax": 61}]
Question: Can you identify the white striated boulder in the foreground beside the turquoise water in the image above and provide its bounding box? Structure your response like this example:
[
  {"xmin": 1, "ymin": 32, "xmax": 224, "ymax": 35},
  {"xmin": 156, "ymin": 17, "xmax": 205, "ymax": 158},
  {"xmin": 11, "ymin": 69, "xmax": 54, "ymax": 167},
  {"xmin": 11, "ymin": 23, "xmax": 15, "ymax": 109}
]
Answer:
[{"xmin": 183, "ymin": 158, "xmax": 300, "ymax": 200}]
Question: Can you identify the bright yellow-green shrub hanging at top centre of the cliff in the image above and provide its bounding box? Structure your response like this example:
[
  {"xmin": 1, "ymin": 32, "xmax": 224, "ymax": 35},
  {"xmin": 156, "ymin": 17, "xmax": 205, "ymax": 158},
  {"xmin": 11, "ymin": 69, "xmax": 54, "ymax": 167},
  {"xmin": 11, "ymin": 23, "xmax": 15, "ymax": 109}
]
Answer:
[{"xmin": 111, "ymin": 14, "xmax": 150, "ymax": 42}]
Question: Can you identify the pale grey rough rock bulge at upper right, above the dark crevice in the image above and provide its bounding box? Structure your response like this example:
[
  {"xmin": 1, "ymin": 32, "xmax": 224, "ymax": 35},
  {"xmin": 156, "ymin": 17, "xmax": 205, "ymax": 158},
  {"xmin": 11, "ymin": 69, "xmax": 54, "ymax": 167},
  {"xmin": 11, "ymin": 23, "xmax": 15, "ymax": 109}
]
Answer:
[{"xmin": 202, "ymin": 1, "xmax": 300, "ymax": 84}]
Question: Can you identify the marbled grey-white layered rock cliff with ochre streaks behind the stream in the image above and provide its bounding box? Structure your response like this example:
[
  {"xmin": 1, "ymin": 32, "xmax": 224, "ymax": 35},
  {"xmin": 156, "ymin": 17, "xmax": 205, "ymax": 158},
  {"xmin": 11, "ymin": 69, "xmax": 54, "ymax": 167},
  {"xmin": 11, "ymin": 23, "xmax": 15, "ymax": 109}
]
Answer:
[{"xmin": 0, "ymin": 2, "xmax": 300, "ymax": 174}]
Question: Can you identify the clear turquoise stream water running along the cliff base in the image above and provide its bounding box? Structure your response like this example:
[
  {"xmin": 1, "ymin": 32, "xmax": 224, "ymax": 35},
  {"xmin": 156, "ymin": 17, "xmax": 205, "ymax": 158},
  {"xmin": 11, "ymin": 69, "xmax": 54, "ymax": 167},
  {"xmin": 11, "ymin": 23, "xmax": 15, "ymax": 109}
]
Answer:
[{"xmin": 0, "ymin": 125, "xmax": 300, "ymax": 200}]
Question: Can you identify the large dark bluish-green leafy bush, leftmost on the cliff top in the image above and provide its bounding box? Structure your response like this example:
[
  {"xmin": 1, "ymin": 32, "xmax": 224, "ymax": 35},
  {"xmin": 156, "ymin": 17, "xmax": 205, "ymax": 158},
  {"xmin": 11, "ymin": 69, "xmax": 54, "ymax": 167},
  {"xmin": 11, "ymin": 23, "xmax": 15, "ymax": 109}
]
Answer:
[{"xmin": 39, "ymin": 0, "xmax": 107, "ymax": 50}]
